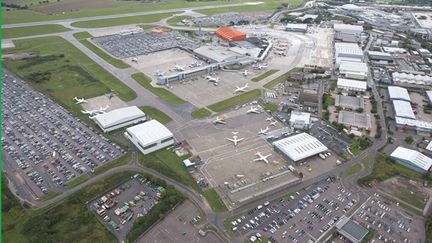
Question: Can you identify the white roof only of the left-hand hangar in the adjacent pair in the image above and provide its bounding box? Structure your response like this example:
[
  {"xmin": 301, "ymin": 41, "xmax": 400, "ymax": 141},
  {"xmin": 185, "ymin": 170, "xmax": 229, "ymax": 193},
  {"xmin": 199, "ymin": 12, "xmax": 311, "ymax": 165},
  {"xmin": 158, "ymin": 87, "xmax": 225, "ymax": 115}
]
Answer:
[{"xmin": 94, "ymin": 106, "xmax": 145, "ymax": 128}]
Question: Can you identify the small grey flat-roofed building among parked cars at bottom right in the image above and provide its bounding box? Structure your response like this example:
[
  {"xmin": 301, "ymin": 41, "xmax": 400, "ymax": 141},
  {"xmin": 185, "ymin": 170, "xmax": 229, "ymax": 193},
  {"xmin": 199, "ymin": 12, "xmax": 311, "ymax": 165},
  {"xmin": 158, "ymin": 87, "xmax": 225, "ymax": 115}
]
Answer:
[{"xmin": 336, "ymin": 215, "xmax": 369, "ymax": 243}]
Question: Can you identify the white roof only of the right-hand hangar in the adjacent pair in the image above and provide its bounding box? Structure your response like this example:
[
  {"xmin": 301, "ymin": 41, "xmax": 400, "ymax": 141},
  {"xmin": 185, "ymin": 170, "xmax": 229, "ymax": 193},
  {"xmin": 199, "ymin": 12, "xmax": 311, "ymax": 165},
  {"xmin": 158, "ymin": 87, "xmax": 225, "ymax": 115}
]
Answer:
[{"xmin": 126, "ymin": 120, "xmax": 173, "ymax": 146}]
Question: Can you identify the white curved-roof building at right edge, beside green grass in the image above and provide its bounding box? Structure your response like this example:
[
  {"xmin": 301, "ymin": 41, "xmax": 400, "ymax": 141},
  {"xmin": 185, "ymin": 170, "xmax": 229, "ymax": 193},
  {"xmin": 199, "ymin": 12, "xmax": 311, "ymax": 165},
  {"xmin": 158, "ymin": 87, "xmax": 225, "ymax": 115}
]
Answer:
[{"xmin": 390, "ymin": 146, "xmax": 432, "ymax": 173}]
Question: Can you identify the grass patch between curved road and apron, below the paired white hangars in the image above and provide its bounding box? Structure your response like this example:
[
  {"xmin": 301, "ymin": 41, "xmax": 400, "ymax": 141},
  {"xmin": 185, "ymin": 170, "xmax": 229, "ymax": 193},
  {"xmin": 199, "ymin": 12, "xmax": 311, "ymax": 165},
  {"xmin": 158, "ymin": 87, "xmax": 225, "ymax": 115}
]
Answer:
[{"xmin": 138, "ymin": 149, "xmax": 227, "ymax": 212}]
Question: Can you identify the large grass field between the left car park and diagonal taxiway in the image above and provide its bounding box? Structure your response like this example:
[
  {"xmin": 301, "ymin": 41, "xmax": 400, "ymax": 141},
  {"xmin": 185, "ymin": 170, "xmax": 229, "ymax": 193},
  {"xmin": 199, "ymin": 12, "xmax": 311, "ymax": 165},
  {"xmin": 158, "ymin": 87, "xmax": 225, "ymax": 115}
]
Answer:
[{"xmin": 3, "ymin": 36, "xmax": 136, "ymax": 111}]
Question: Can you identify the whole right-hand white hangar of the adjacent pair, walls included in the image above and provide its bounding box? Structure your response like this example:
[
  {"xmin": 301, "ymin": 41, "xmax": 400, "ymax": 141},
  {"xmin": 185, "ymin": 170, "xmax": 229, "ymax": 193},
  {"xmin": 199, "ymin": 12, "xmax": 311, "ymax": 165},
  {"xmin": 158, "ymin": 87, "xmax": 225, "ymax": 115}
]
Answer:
[{"xmin": 125, "ymin": 120, "xmax": 174, "ymax": 154}]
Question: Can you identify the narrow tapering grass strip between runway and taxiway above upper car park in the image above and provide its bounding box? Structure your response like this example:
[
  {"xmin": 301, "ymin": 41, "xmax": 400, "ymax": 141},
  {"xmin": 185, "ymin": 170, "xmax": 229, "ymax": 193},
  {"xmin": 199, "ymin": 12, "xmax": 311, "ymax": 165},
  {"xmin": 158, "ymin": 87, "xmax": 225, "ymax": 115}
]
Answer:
[{"xmin": 71, "ymin": 12, "xmax": 180, "ymax": 28}]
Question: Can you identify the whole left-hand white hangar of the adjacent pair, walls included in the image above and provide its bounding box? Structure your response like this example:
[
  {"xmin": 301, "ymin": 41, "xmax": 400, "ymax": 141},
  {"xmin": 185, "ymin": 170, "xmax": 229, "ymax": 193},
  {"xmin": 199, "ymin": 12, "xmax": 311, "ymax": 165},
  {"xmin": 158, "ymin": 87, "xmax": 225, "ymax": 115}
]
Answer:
[{"xmin": 93, "ymin": 106, "xmax": 146, "ymax": 132}]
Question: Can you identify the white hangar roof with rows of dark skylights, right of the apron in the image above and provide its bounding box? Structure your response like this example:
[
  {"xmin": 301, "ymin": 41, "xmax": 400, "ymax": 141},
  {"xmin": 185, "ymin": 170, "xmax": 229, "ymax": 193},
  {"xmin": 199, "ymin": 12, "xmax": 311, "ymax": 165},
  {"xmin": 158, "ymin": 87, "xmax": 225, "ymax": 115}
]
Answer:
[{"xmin": 273, "ymin": 133, "xmax": 328, "ymax": 161}]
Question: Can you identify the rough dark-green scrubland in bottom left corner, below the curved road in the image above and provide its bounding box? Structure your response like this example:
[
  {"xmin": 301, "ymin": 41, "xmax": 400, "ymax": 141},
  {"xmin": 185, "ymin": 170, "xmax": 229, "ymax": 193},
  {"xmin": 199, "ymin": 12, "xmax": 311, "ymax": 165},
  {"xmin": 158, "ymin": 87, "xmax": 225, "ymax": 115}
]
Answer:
[{"xmin": 2, "ymin": 172, "xmax": 134, "ymax": 243}]
